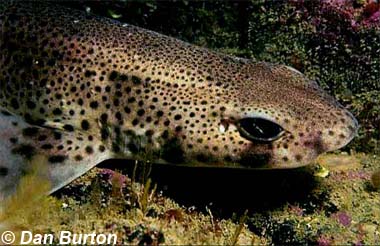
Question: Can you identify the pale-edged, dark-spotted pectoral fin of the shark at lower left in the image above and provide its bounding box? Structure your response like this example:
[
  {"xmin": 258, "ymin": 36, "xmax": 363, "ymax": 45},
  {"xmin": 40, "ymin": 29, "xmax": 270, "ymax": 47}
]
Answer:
[{"xmin": 0, "ymin": 108, "xmax": 110, "ymax": 202}]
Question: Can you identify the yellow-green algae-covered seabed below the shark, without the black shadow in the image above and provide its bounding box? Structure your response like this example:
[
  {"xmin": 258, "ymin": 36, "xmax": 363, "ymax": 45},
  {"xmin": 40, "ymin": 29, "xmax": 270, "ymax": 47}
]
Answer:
[{"xmin": 3, "ymin": 154, "xmax": 380, "ymax": 245}]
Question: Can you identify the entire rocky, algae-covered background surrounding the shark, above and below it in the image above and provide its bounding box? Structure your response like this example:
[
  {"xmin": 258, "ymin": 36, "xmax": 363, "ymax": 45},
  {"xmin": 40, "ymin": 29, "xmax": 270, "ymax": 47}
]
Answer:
[{"xmin": 0, "ymin": 0, "xmax": 380, "ymax": 245}]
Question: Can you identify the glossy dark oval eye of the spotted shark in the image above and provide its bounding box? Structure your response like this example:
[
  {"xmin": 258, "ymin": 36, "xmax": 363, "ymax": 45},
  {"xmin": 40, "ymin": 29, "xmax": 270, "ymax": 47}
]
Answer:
[{"xmin": 237, "ymin": 118, "xmax": 284, "ymax": 142}]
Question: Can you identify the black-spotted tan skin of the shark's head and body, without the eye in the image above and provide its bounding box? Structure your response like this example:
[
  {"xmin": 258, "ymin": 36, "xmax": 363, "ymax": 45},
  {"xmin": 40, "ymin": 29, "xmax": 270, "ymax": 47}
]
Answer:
[{"xmin": 0, "ymin": 2, "xmax": 358, "ymax": 200}]
